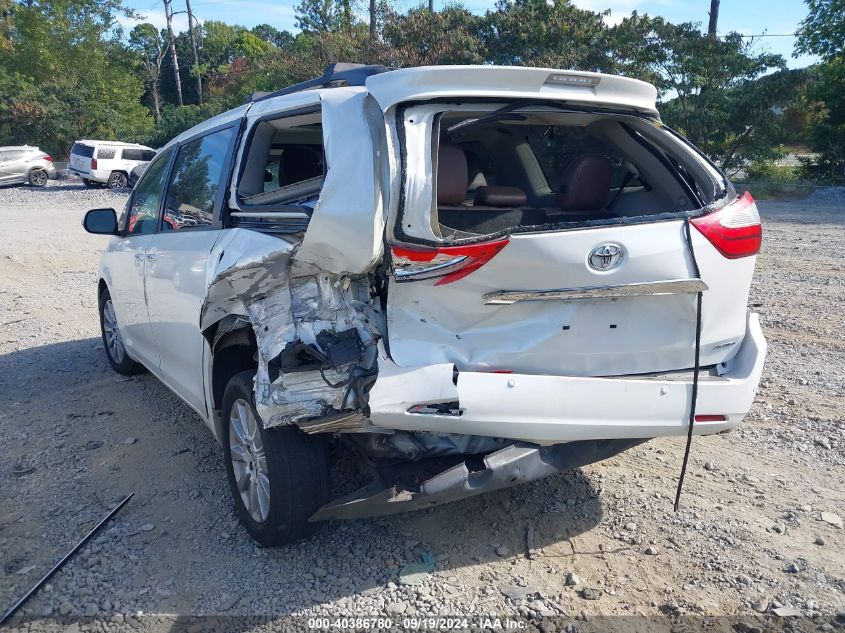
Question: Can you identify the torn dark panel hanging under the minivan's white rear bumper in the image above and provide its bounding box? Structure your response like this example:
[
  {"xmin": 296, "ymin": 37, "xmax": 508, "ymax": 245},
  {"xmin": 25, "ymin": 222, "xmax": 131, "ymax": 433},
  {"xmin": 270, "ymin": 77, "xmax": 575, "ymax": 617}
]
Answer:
[{"xmin": 310, "ymin": 439, "xmax": 647, "ymax": 521}]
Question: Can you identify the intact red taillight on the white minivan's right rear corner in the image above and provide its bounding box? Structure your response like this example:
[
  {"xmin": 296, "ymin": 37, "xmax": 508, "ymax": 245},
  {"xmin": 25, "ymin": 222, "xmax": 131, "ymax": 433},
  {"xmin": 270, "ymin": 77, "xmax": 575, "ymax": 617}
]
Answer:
[{"xmin": 690, "ymin": 191, "xmax": 763, "ymax": 259}]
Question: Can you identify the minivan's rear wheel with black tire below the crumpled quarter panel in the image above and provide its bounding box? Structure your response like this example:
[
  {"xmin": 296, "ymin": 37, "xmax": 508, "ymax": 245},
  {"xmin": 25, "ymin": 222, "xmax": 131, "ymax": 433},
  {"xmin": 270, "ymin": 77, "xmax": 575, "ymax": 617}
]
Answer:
[{"xmin": 221, "ymin": 369, "xmax": 331, "ymax": 547}]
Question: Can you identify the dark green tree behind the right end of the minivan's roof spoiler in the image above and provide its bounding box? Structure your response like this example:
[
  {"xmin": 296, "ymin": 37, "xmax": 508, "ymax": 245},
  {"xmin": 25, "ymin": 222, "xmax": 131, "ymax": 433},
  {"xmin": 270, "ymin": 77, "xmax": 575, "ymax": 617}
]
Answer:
[{"xmin": 611, "ymin": 12, "xmax": 788, "ymax": 173}]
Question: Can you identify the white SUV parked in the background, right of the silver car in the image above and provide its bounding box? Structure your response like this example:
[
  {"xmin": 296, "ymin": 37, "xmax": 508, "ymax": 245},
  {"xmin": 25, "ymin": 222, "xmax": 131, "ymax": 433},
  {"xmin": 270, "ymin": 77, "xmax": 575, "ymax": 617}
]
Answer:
[{"xmin": 68, "ymin": 140, "xmax": 155, "ymax": 189}]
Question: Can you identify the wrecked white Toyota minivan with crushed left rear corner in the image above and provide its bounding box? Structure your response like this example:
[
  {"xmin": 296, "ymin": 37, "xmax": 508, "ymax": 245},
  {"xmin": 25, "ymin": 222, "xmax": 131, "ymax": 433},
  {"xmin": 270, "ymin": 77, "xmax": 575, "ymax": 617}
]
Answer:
[{"xmin": 84, "ymin": 64, "xmax": 766, "ymax": 545}]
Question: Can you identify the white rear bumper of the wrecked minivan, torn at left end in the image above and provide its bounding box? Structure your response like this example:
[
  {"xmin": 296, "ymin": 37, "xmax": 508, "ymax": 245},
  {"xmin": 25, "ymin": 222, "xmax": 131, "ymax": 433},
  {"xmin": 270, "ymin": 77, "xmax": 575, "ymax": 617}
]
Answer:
[{"xmin": 369, "ymin": 313, "xmax": 766, "ymax": 444}]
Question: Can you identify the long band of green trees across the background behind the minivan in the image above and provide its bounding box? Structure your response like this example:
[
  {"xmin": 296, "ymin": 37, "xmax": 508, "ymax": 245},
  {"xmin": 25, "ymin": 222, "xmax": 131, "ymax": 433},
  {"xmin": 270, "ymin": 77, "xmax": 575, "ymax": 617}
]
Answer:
[{"xmin": 0, "ymin": 0, "xmax": 845, "ymax": 180}]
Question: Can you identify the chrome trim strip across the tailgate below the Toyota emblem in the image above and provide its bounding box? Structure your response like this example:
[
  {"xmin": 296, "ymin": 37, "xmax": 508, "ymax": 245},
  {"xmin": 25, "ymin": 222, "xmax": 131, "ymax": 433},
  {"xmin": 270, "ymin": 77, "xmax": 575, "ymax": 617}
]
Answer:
[{"xmin": 484, "ymin": 279, "xmax": 707, "ymax": 305}]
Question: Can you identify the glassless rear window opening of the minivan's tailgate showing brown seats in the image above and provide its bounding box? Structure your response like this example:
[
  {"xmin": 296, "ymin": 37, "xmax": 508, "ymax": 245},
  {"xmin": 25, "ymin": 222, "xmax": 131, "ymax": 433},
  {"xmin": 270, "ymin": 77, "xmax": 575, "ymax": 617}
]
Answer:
[{"xmin": 403, "ymin": 104, "xmax": 726, "ymax": 241}]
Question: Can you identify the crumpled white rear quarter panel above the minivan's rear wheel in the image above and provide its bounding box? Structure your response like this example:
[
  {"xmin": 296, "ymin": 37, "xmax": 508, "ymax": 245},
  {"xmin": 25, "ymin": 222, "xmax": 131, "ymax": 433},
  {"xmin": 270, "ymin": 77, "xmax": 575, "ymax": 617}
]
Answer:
[{"xmin": 200, "ymin": 229, "xmax": 384, "ymax": 427}]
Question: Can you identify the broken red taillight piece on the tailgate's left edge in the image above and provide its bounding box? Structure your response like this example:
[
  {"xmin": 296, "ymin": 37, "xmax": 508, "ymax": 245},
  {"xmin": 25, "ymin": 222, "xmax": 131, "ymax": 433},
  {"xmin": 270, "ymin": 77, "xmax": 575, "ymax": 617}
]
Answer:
[{"xmin": 390, "ymin": 239, "xmax": 508, "ymax": 286}]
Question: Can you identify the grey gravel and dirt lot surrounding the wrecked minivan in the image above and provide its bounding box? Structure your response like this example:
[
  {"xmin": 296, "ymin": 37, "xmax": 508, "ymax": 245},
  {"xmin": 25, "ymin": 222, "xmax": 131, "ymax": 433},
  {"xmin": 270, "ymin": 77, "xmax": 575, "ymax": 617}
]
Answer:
[{"xmin": 0, "ymin": 186, "xmax": 845, "ymax": 626}]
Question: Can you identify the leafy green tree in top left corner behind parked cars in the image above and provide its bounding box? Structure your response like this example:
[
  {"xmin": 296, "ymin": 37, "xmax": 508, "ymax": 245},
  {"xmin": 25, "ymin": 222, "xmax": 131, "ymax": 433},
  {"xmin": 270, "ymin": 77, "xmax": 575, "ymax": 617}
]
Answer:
[{"xmin": 0, "ymin": 0, "xmax": 153, "ymax": 155}]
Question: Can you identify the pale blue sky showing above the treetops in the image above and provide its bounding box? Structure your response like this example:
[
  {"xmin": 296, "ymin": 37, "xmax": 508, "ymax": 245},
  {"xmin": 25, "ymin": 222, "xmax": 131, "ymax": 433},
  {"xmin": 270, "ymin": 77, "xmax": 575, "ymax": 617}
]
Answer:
[{"xmin": 124, "ymin": 0, "xmax": 817, "ymax": 68}]
